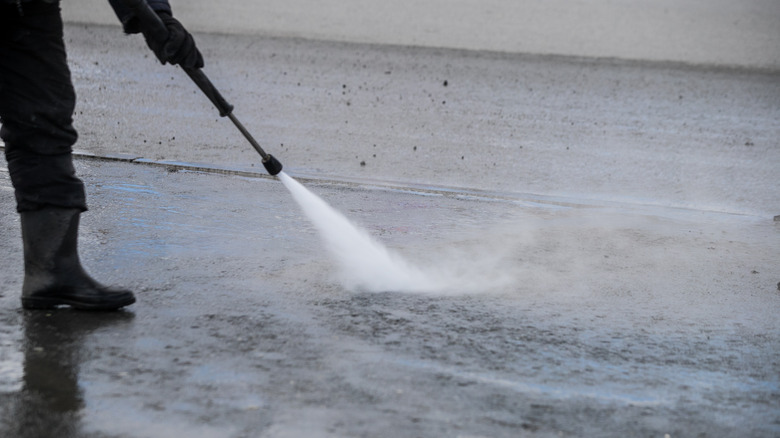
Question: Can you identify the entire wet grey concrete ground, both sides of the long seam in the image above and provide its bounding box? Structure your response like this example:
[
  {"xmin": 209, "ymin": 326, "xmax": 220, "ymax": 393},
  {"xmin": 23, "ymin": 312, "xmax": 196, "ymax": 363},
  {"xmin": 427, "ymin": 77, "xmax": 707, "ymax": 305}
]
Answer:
[{"xmin": 0, "ymin": 19, "xmax": 780, "ymax": 438}]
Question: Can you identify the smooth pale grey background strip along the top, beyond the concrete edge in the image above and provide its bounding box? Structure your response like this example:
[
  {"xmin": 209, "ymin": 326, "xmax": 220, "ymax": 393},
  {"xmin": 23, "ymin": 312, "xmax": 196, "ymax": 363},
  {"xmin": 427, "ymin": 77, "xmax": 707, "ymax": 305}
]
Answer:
[{"xmin": 63, "ymin": 0, "xmax": 780, "ymax": 69}]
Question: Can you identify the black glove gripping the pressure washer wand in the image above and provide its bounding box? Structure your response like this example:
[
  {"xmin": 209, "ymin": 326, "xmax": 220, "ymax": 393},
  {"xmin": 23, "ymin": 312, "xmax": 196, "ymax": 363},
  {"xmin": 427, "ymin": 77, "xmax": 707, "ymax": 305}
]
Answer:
[{"xmin": 140, "ymin": 11, "xmax": 203, "ymax": 69}]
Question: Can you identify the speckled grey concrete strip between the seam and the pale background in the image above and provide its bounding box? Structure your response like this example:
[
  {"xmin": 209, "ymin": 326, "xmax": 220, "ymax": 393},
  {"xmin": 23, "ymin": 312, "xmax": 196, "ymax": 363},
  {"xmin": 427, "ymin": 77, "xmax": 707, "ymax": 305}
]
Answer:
[{"xmin": 59, "ymin": 26, "xmax": 780, "ymax": 217}]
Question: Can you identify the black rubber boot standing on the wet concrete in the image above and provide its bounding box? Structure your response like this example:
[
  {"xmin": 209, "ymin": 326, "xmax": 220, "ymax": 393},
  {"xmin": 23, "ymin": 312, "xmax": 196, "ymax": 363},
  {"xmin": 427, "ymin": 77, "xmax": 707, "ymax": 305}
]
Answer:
[{"xmin": 21, "ymin": 207, "xmax": 135, "ymax": 310}]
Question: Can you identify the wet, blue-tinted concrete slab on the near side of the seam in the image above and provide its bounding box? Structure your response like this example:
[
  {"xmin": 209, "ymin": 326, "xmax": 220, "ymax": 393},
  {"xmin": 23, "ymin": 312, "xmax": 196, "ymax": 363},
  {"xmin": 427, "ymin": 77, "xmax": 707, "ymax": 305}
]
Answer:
[{"xmin": 0, "ymin": 159, "xmax": 780, "ymax": 437}]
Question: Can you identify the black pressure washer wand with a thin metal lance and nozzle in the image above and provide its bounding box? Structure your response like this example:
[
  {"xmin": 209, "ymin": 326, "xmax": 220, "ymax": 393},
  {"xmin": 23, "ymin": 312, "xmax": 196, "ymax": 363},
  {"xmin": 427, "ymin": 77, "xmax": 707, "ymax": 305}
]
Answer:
[{"xmin": 124, "ymin": 0, "xmax": 282, "ymax": 175}]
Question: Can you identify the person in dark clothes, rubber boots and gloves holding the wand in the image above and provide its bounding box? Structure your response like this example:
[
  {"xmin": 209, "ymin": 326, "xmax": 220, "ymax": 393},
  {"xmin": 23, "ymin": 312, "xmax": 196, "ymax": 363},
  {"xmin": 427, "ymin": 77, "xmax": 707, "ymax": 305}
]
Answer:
[{"xmin": 0, "ymin": 0, "xmax": 203, "ymax": 310}]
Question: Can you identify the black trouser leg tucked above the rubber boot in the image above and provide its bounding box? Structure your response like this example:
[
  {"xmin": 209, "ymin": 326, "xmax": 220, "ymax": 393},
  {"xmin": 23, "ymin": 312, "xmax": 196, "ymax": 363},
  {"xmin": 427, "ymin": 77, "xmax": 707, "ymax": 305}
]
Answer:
[{"xmin": 0, "ymin": 1, "xmax": 87, "ymax": 212}]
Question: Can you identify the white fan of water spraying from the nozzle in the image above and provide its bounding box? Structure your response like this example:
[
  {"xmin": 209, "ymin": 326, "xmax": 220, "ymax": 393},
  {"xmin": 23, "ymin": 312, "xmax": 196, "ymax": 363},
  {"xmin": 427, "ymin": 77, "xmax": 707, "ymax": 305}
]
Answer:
[{"xmin": 278, "ymin": 172, "xmax": 445, "ymax": 292}]
